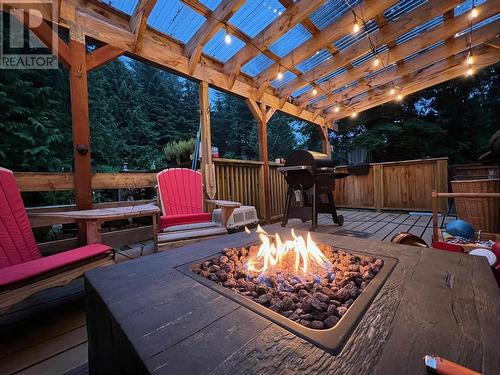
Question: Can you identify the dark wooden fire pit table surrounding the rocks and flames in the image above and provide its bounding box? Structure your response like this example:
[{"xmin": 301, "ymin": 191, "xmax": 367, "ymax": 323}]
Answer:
[{"xmin": 85, "ymin": 226, "xmax": 500, "ymax": 375}]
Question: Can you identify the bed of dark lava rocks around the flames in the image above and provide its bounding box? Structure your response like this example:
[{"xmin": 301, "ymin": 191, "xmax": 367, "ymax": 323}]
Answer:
[{"xmin": 192, "ymin": 244, "xmax": 384, "ymax": 330}]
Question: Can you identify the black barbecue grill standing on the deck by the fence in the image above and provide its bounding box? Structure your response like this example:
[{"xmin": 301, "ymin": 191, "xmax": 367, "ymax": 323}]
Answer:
[{"xmin": 278, "ymin": 150, "xmax": 349, "ymax": 231}]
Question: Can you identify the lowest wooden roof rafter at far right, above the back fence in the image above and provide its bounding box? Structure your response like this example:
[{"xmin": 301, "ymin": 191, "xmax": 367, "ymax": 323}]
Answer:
[{"xmin": 327, "ymin": 45, "xmax": 500, "ymax": 121}]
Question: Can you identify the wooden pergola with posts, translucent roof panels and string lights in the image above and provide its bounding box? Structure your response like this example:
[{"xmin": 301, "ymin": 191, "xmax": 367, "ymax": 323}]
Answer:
[{"xmin": 4, "ymin": 0, "xmax": 500, "ymax": 226}]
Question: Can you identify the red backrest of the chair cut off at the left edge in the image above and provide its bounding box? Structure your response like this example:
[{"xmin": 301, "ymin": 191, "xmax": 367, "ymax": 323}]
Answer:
[{"xmin": 0, "ymin": 168, "xmax": 41, "ymax": 268}]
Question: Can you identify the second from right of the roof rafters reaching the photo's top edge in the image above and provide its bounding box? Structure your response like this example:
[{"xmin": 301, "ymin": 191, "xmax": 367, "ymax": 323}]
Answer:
[{"xmin": 256, "ymin": 0, "xmax": 397, "ymax": 85}]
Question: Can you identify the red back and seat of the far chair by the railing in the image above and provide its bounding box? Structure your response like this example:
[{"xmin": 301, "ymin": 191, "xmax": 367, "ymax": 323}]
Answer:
[{"xmin": 156, "ymin": 168, "xmax": 212, "ymax": 230}]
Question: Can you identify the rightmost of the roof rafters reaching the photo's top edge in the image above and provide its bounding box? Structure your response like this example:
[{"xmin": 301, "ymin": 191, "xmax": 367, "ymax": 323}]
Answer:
[{"xmin": 280, "ymin": 0, "xmax": 461, "ymax": 97}]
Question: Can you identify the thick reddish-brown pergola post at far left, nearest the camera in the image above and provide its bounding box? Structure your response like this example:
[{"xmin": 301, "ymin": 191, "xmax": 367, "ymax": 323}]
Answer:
[{"xmin": 69, "ymin": 29, "xmax": 92, "ymax": 244}]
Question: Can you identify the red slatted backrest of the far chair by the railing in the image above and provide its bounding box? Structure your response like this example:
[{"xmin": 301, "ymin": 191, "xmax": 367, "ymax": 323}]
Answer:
[{"xmin": 156, "ymin": 168, "xmax": 203, "ymax": 215}]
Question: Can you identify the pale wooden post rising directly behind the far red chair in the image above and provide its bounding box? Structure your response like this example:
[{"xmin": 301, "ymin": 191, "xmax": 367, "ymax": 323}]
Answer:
[{"xmin": 200, "ymin": 81, "xmax": 217, "ymax": 199}]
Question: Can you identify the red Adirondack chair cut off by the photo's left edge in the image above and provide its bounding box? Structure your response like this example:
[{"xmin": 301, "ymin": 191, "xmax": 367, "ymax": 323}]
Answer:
[{"xmin": 0, "ymin": 168, "xmax": 113, "ymax": 314}]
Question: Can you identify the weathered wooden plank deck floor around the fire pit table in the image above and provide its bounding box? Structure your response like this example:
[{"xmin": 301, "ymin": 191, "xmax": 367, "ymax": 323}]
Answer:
[{"xmin": 0, "ymin": 210, "xmax": 453, "ymax": 375}]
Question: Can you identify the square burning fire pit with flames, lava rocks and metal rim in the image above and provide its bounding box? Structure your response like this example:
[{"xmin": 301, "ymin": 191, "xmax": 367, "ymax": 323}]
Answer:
[{"xmin": 183, "ymin": 228, "xmax": 397, "ymax": 353}]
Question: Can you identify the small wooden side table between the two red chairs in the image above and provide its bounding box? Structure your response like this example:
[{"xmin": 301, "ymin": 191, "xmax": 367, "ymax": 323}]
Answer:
[{"xmin": 30, "ymin": 204, "xmax": 160, "ymax": 253}]
